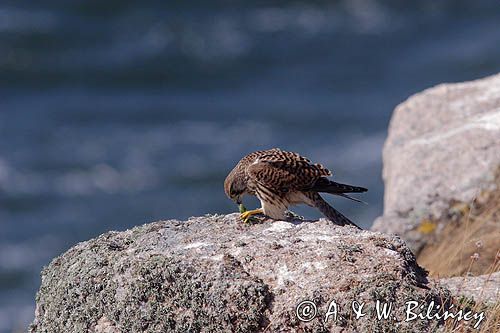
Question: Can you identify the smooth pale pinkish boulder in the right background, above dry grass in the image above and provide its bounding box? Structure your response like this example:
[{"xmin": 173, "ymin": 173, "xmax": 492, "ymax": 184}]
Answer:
[{"xmin": 373, "ymin": 74, "xmax": 500, "ymax": 250}]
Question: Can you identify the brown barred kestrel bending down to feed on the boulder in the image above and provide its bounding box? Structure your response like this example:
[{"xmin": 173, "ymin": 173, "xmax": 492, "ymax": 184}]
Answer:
[{"xmin": 224, "ymin": 148, "xmax": 367, "ymax": 228}]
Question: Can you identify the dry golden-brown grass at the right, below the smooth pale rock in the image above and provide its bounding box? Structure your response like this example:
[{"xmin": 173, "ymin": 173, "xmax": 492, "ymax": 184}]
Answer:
[{"xmin": 417, "ymin": 170, "xmax": 500, "ymax": 333}]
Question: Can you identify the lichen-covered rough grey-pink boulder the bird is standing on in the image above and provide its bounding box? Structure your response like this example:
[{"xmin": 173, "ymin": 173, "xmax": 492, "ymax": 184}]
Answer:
[{"xmin": 31, "ymin": 214, "xmax": 446, "ymax": 333}]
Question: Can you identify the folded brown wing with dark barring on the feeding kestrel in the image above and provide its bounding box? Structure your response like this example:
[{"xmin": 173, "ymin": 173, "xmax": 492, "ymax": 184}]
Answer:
[{"xmin": 246, "ymin": 149, "xmax": 331, "ymax": 193}]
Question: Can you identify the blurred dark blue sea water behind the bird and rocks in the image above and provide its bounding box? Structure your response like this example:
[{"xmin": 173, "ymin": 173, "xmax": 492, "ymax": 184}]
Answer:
[{"xmin": 0, "ymin": 0, "xmax": 500, "ymax": 333}]
